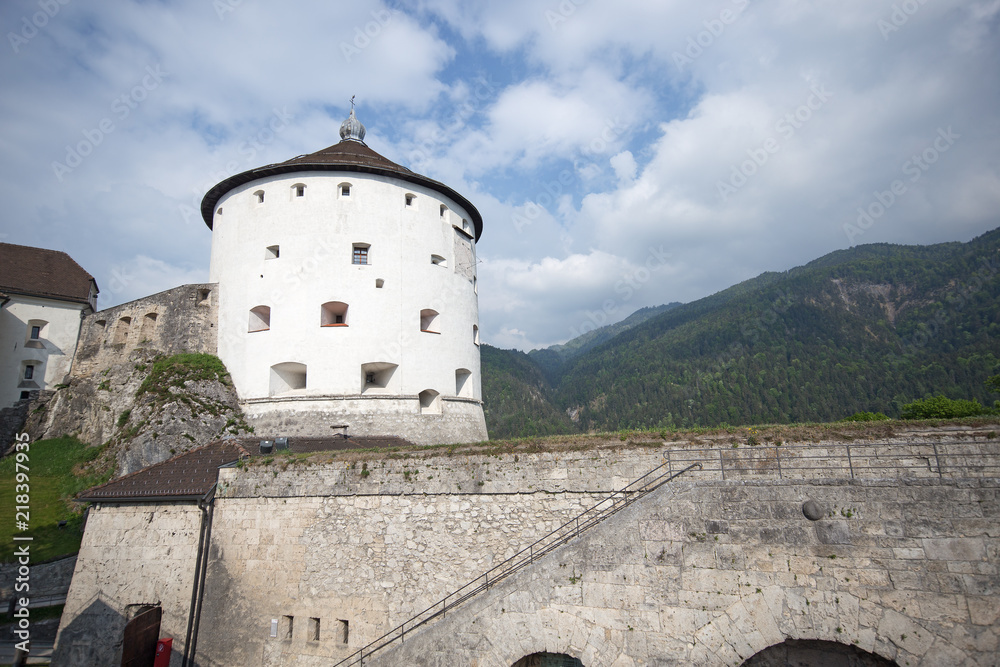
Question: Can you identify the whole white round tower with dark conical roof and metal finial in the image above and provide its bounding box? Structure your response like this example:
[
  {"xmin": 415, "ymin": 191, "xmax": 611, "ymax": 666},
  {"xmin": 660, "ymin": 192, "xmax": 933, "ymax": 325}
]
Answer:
[{"xmin": 201, "ymin": 109, "xmax": 487, "ymax": 444}]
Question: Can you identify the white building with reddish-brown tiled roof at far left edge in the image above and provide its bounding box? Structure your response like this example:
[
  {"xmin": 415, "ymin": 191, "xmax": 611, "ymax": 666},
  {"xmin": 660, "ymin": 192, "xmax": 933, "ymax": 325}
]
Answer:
[{"xmin": 0, "ymin": 243, "xmax": 98, "ymax": 408}]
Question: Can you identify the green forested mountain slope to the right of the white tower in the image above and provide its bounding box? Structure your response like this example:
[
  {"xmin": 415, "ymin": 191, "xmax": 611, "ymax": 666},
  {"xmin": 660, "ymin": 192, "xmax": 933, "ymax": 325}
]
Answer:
[{"xmin": 483, "ymin": 230, "xmax": 1000, "ymax": 437}]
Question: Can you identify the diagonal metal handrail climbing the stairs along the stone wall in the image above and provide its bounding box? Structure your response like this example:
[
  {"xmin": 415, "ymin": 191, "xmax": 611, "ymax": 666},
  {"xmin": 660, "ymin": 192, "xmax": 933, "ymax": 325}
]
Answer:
[{"xmin": 334, "ymin": 461, "xmax": 702, "ymax": 667}]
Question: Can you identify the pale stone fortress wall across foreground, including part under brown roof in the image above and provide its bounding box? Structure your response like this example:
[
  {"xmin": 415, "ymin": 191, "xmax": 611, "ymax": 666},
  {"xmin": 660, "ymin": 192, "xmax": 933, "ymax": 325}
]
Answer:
[{"xmin": 58, "ymin": 427, "xmax": 1000, "ymax": 667}]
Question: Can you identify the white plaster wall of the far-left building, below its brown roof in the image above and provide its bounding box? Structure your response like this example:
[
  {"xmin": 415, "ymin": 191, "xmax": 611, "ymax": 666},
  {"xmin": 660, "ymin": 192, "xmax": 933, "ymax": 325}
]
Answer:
[{"xmin": 0, "ymin": 295, "xmax": 86, "ymax": 407}]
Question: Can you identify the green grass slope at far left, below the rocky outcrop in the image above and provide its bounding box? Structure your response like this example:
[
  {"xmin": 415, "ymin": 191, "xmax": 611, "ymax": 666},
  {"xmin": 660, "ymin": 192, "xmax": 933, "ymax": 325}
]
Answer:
[{"xmin": 0, "ymin": 436, "xmax": 111, "ymax": 563}]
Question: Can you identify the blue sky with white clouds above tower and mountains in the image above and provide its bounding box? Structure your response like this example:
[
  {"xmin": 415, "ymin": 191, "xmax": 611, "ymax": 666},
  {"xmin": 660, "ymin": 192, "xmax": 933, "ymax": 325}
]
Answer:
[{"xmin": 0, "ymin": 0, "xmax": 1000, "ymax": 350}]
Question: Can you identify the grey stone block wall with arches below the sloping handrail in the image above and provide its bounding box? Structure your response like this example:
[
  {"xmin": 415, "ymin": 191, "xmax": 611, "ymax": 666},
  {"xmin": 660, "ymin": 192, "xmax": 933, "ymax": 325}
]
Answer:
[{"xmin": 376, "ymin": 479, "xmax": 1000, "ymax": 667}]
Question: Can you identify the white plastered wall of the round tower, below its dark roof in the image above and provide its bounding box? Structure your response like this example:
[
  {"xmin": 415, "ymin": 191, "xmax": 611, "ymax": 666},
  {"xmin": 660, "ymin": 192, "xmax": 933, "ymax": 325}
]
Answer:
[{"xmin": 211, "ymin": 172, "xmax": 486, "ymax": 442}]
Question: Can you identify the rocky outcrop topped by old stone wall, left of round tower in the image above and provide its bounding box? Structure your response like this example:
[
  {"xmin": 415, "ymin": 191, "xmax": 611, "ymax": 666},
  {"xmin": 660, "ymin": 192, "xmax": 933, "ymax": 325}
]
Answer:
[{"xmin": 24, "ymin": 284, "xmax": 250, "ymax": 475}]
